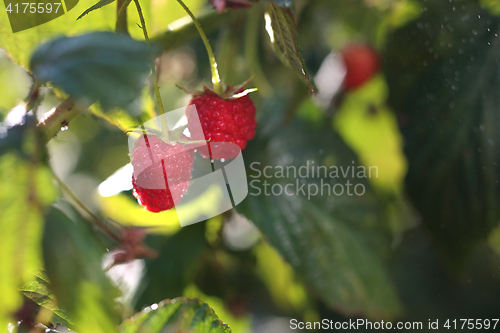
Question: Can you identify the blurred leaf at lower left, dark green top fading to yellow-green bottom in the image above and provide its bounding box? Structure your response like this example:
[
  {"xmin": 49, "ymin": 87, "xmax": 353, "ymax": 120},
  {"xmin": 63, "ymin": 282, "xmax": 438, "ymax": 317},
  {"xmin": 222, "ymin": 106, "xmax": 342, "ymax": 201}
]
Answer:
[{"xmin": 43, "ymin": 202, "xmax": 120, "ymax": 333}]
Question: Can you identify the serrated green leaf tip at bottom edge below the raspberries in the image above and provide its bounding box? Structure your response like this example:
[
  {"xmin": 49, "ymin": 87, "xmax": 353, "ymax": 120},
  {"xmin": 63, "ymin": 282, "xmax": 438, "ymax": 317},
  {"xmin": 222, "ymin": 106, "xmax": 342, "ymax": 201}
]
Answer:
[{"xmin": 120, "ymin": 298, "xmax": 231, "ymax": 333}]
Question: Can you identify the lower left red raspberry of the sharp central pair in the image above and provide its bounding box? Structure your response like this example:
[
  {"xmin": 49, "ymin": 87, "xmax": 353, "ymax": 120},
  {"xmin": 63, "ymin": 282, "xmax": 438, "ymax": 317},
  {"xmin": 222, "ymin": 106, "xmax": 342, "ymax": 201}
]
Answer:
[{"xmin": 131, "ymin": 135, "xmax": 194, "ymax": 213}]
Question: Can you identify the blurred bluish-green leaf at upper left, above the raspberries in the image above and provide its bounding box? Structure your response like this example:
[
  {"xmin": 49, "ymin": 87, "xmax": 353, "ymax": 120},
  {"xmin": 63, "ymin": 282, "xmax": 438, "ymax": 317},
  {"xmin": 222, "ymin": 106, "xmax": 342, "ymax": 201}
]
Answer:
[{"xmin": 30, "ymin": 32, "xmax": 155, "ymax": 111}]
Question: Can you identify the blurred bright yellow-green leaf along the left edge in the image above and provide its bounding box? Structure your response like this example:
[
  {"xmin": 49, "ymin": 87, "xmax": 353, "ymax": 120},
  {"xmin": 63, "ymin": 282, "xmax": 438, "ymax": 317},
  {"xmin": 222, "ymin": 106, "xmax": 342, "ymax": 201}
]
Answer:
[{"xmin": 0, "ymin": 116, "xmax": 56, "ymax": 327}]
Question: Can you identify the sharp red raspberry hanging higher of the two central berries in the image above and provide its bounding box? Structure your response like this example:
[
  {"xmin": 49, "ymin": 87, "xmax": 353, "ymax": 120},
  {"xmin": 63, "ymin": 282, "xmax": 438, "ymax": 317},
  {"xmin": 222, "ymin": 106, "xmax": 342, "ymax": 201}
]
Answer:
[{"xmin": 187, "ymin": 89, "xmax": 257, "ymax": 159}]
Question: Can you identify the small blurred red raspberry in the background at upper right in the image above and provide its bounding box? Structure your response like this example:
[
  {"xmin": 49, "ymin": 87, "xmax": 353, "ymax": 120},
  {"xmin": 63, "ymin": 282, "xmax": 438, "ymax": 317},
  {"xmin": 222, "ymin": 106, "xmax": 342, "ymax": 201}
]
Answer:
[{"xmin": 342, "ymin": 44, "xmax": 380, "ymax": 90}]
